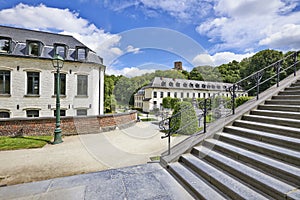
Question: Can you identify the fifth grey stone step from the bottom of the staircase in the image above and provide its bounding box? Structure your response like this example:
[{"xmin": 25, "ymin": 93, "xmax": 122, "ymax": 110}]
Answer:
[{"xmin": 214, "ymin": 132, "xmax": 300, "ymax": 166}]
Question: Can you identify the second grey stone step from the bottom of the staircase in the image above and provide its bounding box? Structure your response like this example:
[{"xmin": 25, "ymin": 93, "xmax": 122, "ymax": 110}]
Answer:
[{"xmin": 181, "ymin": 154, "xmax": 267, "ymax": 199}]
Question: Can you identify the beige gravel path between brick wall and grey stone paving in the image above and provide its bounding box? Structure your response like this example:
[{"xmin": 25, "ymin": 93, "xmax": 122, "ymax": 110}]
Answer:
[{"xmin": 0, "ymin": 122, "xmax": 184, "ymax": 187}]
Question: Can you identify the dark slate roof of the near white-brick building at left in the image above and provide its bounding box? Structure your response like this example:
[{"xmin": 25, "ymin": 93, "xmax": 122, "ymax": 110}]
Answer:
[{"xmin": 0, "ymin": 26, "xmax": 103, "ymax": 64}]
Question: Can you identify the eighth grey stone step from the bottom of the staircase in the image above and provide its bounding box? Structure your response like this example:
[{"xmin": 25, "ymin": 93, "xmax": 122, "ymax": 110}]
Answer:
[{"xmin": 242, "ymin": 115, "xmax": 300, "ymax": 128}]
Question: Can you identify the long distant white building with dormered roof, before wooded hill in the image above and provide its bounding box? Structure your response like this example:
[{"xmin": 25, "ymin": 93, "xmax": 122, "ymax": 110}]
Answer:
[{"xmin": 134, "ymin": 77, "xmax": 247, "ymax": 112}]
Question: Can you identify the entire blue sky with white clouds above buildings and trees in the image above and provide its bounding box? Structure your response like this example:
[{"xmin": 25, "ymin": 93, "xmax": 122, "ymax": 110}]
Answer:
[{"xmin": 0, "ymin": 0, "xmax": 300, "ymax": 76}]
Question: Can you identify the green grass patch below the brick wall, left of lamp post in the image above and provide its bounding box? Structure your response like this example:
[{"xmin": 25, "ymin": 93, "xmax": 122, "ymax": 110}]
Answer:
[{"xmin": 0, "ymin": 136, "xmax": 53, "ymax": 151}]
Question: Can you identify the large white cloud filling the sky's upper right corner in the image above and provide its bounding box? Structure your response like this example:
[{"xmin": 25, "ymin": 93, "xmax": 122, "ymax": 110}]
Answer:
[{"xmin": 196, "ymin": 0, "xmax": 300, "ymax": 52}]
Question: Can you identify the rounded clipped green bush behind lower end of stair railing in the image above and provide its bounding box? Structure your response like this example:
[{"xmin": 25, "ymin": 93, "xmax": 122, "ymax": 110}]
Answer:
[{"xmin": 170, "ymin": 102, "xmax": 199, "ymax": 135}]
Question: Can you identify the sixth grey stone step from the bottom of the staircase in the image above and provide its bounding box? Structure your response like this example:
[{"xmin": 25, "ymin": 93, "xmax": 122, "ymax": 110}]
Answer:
[{"xmin": 223, "ymin": 126, "xmax": 300, "ymax": 152}]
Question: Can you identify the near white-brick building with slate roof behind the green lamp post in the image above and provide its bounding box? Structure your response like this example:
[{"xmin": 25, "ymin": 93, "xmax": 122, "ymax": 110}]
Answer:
[{"xmin": 0, "ymin": 26, "xmax": 105, "ymax": 118}]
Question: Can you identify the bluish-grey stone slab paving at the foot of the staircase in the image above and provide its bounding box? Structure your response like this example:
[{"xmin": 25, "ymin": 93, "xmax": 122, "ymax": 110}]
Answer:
[{"xmin": 0, "ymin": 163, "xmax": 192, "ymax": 200}]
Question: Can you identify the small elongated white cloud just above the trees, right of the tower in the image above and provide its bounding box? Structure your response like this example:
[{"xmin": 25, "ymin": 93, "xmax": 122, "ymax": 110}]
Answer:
[{"xmin": 193, "ymin": 52, "xmax": 254, "ymax": 66}]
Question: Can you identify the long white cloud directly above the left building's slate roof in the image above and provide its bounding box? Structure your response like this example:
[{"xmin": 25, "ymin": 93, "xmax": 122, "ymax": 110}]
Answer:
[{"xmin": 0, "ymin": 3, "xmax": 139, "ymax": 65}]
